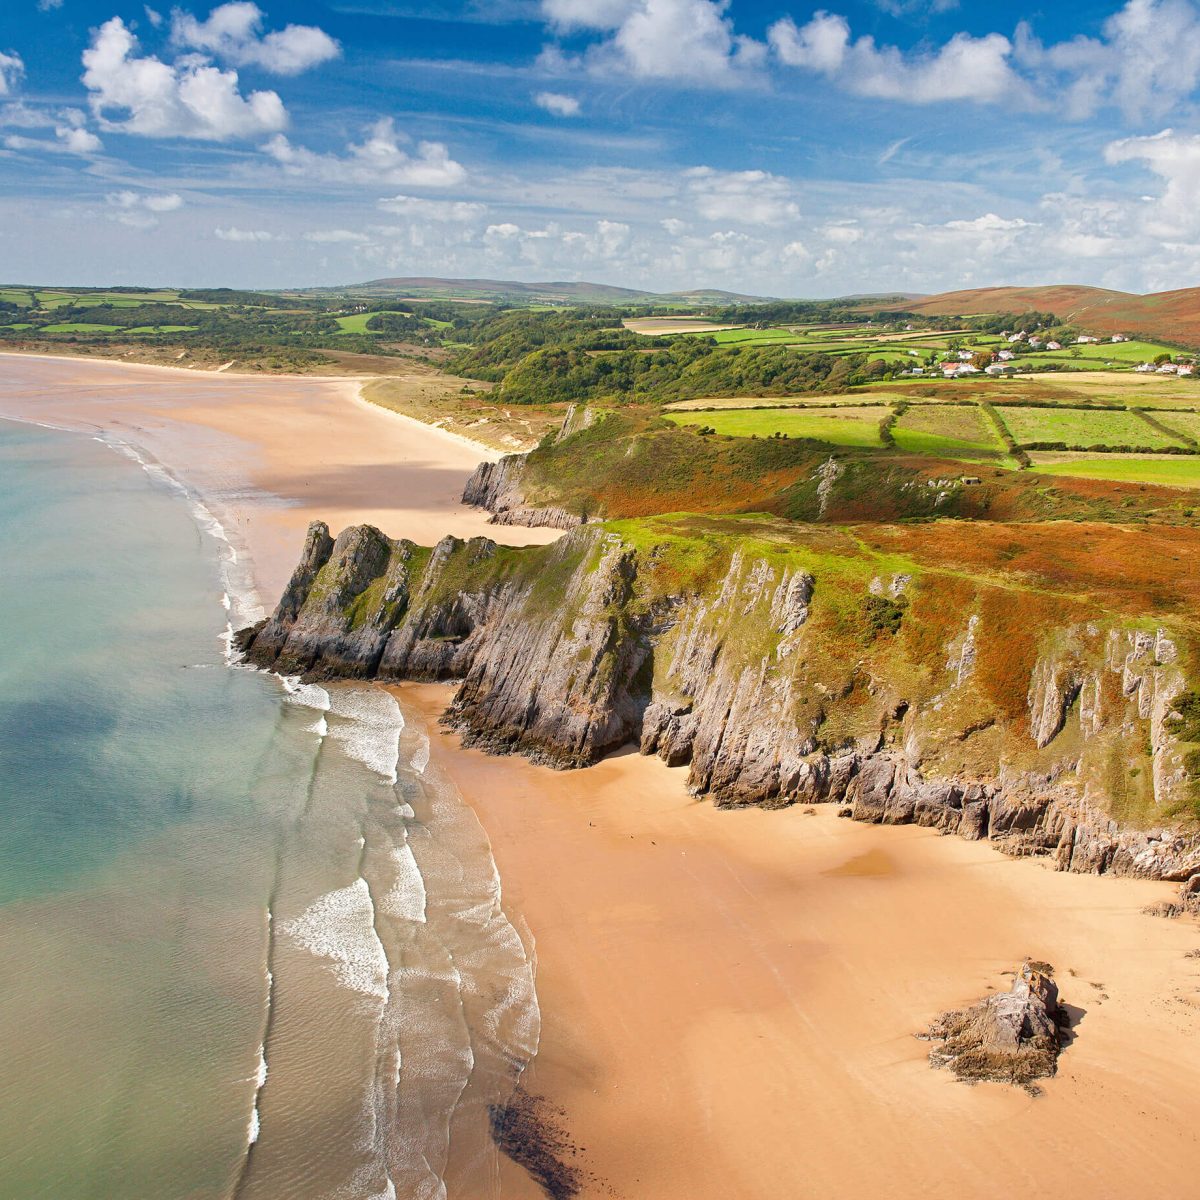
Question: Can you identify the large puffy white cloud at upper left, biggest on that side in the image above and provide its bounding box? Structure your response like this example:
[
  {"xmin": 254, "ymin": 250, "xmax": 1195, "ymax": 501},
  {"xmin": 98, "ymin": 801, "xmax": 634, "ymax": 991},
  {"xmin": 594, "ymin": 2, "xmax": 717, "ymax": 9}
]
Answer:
[{"xmin": 83, "ymin": 17, "xmax": 288, "ymax": 142}]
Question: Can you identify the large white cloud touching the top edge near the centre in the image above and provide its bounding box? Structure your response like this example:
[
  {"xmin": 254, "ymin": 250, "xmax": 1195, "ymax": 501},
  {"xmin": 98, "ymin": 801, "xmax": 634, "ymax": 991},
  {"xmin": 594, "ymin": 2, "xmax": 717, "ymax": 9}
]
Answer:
[{"xmin": 542, "ymin": 0, "xmax": 766, "ymax": 86}]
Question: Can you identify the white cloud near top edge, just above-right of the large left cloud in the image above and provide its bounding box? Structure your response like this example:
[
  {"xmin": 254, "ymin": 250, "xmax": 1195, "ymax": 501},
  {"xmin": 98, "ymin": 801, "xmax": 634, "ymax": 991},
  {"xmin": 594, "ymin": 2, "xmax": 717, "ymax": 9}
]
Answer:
[{"xmin": 170, "ymin": 0, "xmax": 342, "ymax": 76}]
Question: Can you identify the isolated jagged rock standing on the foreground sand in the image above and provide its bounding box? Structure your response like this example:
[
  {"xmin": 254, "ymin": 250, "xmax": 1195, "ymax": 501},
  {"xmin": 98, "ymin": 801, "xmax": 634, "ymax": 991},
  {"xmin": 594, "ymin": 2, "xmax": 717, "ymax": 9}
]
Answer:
[{"xmin": 923, "ymin": 962, "xmax": 1067, "ymax": 1094}]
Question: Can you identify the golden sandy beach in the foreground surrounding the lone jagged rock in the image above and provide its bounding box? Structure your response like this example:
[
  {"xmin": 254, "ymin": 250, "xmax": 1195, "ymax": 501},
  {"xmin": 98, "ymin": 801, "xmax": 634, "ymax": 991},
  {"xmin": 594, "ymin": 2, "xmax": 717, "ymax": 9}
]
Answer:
[{"xmin": 397, "ymin": 685, "xmax": 1200, "ymax": 1200}]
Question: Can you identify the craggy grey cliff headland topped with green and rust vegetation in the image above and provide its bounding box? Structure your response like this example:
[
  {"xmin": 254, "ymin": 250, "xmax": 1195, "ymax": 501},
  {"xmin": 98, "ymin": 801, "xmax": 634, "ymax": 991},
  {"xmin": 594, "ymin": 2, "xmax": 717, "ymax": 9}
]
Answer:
[{"xmin": 241, "ymin": 517, "xmax": 1200, "ymax": 880}]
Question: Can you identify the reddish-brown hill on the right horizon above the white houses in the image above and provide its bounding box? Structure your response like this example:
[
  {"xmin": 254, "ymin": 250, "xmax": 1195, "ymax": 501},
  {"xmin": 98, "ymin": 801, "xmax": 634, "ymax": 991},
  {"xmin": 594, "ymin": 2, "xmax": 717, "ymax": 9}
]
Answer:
[{"xmin": 883, "ymin": 283, "xmax": 1200, "ymax": 346}]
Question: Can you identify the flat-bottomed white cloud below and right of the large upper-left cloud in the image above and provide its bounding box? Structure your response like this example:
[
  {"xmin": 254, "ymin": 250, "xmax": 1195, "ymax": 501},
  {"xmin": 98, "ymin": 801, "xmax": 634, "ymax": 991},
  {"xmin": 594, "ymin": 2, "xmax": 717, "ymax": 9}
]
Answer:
[{"xmin": 264, "ymin": 116, "xmax": 467, "ymax": 187}]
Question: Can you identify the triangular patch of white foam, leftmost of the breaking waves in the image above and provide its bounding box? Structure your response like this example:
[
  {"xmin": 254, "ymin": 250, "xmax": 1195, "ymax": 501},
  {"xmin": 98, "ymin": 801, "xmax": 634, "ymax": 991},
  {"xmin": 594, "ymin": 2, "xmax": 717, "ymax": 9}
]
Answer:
[{"xmin": 280, "ymin": 876, "xmax": 390, "ymax": 1003}]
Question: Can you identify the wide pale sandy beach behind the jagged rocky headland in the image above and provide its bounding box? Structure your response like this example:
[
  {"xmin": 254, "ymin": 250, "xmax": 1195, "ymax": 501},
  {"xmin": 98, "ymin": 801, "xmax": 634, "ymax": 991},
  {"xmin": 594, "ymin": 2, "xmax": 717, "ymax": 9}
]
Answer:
[{"xmin": 0, "ymin": 355, "xmax": 558, "ymax": 605}]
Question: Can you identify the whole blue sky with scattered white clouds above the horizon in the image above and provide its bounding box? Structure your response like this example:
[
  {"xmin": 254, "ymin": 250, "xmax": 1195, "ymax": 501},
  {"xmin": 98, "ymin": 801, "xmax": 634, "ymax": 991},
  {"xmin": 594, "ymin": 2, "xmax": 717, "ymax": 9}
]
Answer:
[{"xmin": 0, "ymin": 0, "xmax": 1200, "ymax": 296}]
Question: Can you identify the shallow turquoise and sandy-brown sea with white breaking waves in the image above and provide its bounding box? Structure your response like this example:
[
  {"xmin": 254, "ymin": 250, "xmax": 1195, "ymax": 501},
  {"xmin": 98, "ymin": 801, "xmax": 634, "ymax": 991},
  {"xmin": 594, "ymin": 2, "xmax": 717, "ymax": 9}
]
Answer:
[{"xmin": 0, "ymin": 421, "xmax": 539, "ymax": 1200}]
